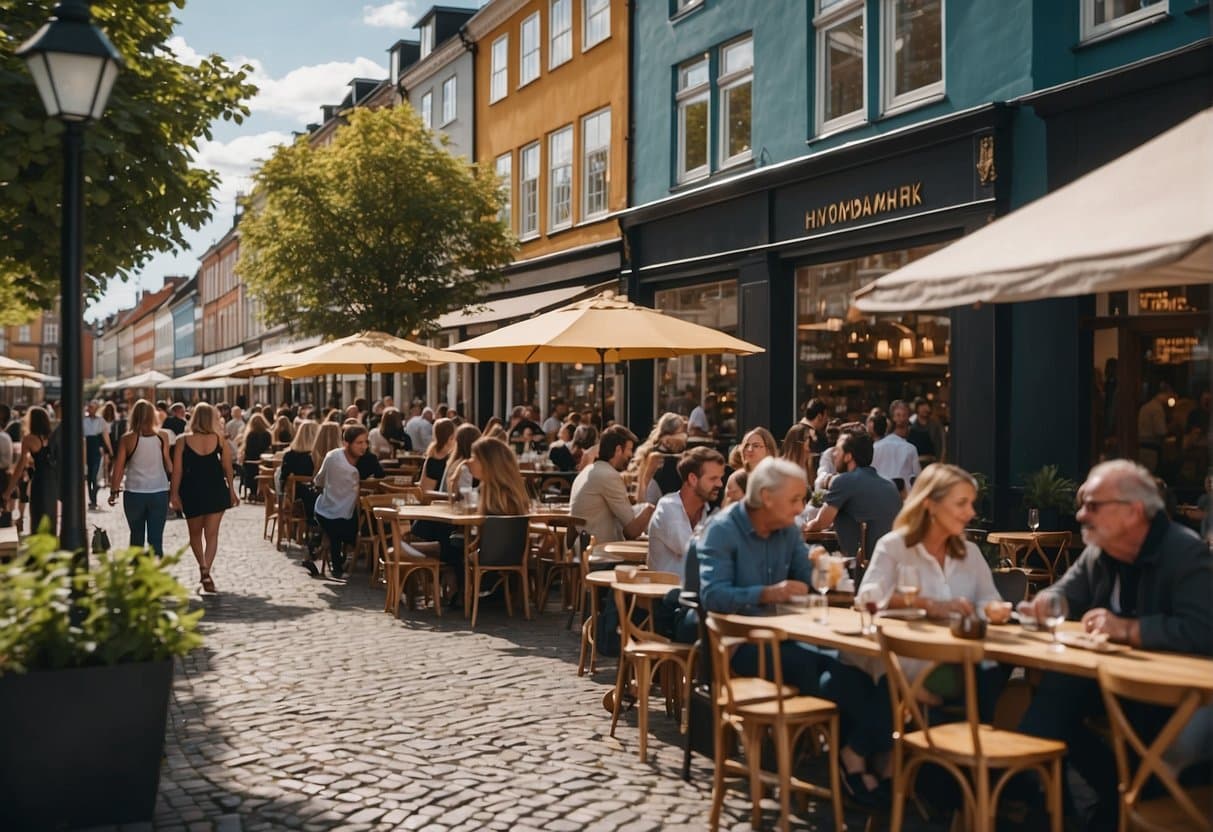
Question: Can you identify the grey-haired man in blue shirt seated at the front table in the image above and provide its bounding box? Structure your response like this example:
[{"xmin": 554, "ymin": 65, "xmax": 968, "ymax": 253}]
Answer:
[{"xmin": 697, "ymin": 457, "xmax": 821, "ymax": 694}]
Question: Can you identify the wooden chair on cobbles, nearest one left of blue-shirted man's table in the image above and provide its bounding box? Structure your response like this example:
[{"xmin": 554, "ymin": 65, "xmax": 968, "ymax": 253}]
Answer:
[{"xmin": 610, "ymin": 570, "xmax": 695, "ymax": 763}]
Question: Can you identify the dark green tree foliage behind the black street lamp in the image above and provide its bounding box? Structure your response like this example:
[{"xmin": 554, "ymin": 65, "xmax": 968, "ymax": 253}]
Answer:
[{"xmin": 0, "ymin": 0, "xmax": 256, "ymax": 323}]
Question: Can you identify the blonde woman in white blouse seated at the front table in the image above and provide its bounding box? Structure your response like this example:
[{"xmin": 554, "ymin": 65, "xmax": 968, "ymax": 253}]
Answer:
[{"xmin": 821, "ymin": 463, "xmax": 1007, "ymax": 804}]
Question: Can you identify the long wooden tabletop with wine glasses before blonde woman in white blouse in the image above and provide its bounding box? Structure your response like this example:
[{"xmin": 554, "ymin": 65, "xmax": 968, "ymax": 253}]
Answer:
[{"xmin": 725, "ymin": 606, "xmax": 1213, "ymax": 694}]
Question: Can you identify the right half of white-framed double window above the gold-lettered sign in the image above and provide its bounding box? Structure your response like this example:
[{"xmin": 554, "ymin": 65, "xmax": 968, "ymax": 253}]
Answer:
[{"xmin": 882, "ymin": 0, "xmax": 944, "ymax": 113}]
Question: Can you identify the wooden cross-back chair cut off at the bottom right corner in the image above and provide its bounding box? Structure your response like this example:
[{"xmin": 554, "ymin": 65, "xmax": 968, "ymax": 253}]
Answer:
[{"xmin": 1098, "ymin": 663, "xmax": 1213, "ymax": 832}]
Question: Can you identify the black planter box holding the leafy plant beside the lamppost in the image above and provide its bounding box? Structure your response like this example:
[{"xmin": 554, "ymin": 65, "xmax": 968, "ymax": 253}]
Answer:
[{"xmin": 0, "ymin": 660, "xmax": 172, "ymax": 830}]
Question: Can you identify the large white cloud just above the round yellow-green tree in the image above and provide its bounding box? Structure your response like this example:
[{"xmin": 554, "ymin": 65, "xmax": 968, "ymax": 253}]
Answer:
[{"xmin": 235, "ymin": 57, "xmax": 387, "ymax": 125}]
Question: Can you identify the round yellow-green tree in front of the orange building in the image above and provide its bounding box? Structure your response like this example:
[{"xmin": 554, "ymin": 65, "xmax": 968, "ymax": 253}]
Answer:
[{"xmin": 238, "ymin": 107, "xmax": 516, "ymax": 337}]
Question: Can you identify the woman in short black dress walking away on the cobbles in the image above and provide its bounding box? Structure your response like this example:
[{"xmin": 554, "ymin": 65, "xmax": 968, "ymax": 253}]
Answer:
[{"xmin": 169, "ymin": 401, "xmax": 240, "ymax": 593}]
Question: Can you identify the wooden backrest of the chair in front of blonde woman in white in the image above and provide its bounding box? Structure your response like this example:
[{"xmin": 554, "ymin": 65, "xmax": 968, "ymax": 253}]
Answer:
[{"xmin": 879, "ymin": 627, "xmax": 984, "ymax": 756}]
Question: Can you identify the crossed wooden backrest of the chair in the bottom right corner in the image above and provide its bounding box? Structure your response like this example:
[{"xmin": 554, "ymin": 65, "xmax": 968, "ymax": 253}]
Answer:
[{"xmin": 1098, "ymin": 663, "xmax": 1213, "ymax": 832}]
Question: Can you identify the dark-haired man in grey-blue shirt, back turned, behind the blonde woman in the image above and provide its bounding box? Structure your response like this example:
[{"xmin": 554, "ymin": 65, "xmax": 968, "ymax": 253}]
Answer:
[{"xmin": 804, "ymin": 433, "xmax": 901, "ymax": 558}]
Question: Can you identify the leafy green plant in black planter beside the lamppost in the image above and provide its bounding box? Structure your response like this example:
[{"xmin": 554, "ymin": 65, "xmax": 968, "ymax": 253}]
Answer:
[{"xmin": 0, "ymin": 535, "xmax": 203, "ymax": 828}]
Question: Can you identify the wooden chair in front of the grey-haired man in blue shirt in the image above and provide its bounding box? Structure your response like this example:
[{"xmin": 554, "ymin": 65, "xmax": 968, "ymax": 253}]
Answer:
[{"xmin": 707, "ymin": 615, "xmax": 845, "ymax": 832}]
